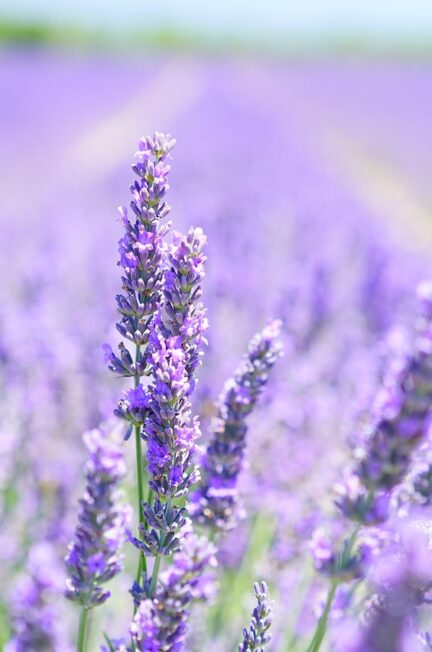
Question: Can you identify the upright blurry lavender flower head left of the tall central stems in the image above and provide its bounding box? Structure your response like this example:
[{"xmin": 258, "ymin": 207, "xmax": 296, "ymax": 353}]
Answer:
[{"xmin": 66, "ymin": 429, "xmax": 129, "ymax": 609}]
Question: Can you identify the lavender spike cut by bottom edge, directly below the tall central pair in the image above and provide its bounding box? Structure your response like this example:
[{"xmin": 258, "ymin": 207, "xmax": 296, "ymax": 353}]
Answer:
[{"xmin": 127, "ymin": 532, "xmax": 216, "ymax": 652}]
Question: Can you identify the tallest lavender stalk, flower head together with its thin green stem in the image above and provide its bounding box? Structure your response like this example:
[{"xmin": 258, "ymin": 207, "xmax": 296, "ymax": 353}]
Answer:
[{"xmin": 104, "ymin": 132, "xmax": 175, "ymax": 579}]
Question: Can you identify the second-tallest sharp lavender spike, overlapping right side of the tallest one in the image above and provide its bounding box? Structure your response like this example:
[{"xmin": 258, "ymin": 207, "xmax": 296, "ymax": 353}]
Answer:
[{"xmin": 128, "ymin": 222, "xmax": 207, "ymax": 597}]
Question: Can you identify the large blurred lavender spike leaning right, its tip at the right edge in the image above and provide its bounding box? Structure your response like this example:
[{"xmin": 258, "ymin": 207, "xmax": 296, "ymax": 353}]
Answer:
[{"xmin": 336, "ymin": 282, "xmax": 432, "ymax": 524}]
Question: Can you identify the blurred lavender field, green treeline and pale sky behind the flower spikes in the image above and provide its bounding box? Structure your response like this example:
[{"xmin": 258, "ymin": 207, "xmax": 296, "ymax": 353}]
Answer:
[{"xmin": 0, "ymin": 0, "xmax": 432, "ymax": 651}]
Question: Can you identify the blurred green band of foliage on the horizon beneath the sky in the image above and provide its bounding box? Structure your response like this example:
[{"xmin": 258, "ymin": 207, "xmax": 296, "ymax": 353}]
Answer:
[{"xmin": 0, "ymin": 17, "xmax": 432, "ymax": 59}]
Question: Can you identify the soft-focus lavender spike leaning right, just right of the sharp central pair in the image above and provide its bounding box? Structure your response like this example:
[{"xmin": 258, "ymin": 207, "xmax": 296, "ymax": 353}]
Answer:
[{"xmin": 191, "ymin": 321, "xmax": 281, "ymax": 530}]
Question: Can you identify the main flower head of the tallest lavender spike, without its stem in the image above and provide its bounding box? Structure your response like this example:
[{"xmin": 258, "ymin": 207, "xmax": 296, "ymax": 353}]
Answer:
[{"xmin": 105, "ymin": 133, "xmax": 175, "ymax": 376}]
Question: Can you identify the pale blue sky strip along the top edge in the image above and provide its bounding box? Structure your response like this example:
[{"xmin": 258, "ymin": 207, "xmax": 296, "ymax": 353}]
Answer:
[{"xmin": 0, "ymin": 0, "xmax": 432, "ymax": 41}]
